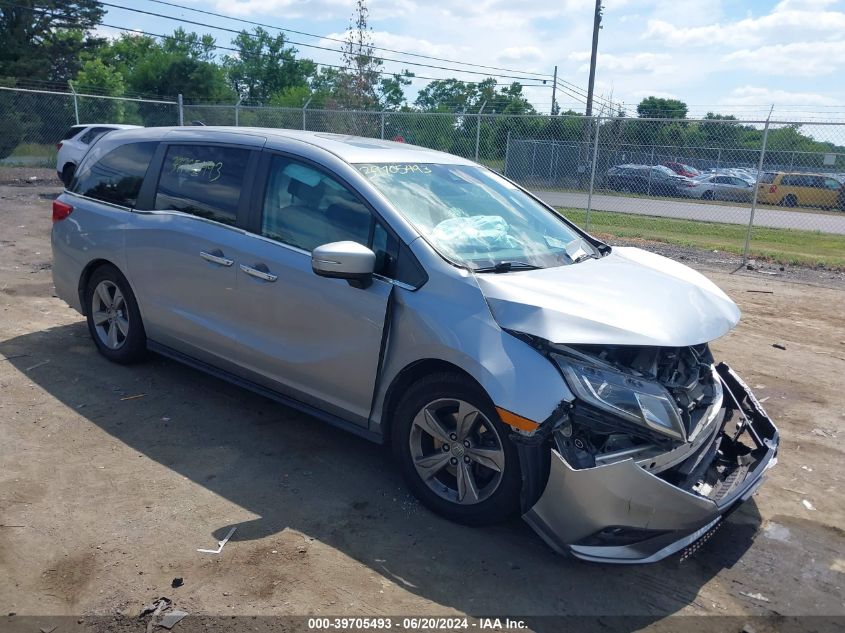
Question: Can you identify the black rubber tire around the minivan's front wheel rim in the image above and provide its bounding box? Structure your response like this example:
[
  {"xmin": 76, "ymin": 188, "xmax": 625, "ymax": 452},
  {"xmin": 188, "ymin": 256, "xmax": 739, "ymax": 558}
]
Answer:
[{"xmin": 391, "ymin": 373, "xmax": 522, "ymax": 525}]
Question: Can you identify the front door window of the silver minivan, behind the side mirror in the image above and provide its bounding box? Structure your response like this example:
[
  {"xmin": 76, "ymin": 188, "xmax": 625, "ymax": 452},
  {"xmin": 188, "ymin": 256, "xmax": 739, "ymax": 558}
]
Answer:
[{"xmin": 261, "ymin": 156, "xmax": 398, "ymax": 276}]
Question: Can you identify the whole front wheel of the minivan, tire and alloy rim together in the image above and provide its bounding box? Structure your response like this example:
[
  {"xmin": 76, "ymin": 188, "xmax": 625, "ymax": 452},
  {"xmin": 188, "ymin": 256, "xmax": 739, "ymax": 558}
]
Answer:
[{"xmin": 392, "ymin": 373, "xmax": 521, "ymax": 525}]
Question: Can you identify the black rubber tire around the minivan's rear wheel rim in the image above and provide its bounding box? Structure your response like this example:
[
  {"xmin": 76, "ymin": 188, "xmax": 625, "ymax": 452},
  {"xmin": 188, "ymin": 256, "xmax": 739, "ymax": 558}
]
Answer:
[{"xmin": 85, "ymin": 264, "xmax": 147, "ymax": 365}]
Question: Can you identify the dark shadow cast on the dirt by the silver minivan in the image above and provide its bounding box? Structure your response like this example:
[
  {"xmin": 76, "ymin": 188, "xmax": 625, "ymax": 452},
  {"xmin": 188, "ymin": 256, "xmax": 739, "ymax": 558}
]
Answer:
[{"xmin": 0, "ymin": 322, "xmax": 760, "ymax": 631}]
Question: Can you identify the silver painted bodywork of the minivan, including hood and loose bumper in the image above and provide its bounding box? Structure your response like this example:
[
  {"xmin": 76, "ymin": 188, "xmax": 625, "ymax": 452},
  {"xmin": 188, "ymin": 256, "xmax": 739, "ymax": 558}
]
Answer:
[{"xmin": 52, "ymin": 128, "xmax": 780, "ymax": 561}]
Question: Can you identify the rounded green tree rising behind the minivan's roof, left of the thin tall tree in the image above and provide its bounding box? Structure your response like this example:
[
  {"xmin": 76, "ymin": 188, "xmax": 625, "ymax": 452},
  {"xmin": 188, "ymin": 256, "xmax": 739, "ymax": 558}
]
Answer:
[{"xmin": 223, "ymin": 27, "xmax": 316, "ymax": 103}]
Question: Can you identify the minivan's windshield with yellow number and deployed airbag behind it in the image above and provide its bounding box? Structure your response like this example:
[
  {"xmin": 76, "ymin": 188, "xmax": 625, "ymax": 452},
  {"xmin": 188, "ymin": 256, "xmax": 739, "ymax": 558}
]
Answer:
[{"xmin": 356, "ymin": 163, "xmax": 598, "ymax": 272}]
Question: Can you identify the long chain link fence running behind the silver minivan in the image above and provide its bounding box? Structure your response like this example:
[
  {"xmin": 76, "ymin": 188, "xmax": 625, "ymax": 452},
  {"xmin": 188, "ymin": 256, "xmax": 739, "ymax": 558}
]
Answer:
[{"xmin": 0, "ymin": 88, "xmax": 845, "ymax": 267}]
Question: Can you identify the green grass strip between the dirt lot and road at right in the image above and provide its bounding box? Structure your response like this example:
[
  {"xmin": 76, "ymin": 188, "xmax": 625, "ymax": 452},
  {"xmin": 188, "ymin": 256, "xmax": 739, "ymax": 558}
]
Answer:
[{"xmin": 558, "ymin": 208, "xmax": 845, "ymax": 270}]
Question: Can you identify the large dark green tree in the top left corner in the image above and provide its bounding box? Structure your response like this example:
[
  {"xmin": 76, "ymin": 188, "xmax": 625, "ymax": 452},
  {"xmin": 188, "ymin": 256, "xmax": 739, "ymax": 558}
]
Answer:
[{"xmin": 0, "ymin": 0, "xmax": 103, "ymax": 82}]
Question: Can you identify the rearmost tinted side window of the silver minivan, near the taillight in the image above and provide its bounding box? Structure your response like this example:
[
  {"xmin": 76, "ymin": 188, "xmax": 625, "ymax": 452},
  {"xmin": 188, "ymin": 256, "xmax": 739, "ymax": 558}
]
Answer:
[{"xmin": 70, "ymin": 142, "xmax": 158, "ymax": 207}]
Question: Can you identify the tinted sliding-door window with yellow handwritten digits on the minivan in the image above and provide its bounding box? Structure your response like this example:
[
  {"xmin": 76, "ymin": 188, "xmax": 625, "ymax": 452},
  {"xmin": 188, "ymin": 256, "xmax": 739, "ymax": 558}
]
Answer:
[{"xmin": 155, "ymin": 145, "xmax": 250, "ymax": 225}]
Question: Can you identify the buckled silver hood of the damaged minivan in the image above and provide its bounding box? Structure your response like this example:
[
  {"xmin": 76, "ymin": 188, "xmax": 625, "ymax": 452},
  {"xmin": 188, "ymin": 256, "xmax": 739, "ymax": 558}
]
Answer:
[{"xmin": 475, "ymin": 247, "xmax": 740, "ymax": 347}]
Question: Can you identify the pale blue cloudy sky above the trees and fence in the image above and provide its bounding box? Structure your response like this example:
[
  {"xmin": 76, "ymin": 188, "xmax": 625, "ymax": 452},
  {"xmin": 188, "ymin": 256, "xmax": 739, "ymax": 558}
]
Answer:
[{"xmin": 102, "ymin": 0, "xmax": 845, "ymax": 120}]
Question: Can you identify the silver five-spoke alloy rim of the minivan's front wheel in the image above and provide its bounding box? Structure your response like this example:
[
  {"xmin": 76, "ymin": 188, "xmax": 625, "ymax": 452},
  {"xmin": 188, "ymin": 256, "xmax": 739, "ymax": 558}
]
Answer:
[{"xmin": 408, "ymin": 398, "xmax": 505, "ymax": 505}]
